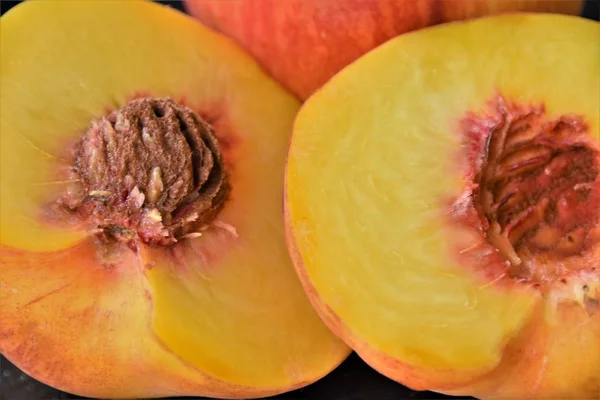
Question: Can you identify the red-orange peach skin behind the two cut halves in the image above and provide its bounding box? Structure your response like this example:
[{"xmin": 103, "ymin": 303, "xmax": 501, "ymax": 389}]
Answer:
[{"xmin": 184, "ymin": 0, "xmax": 584, "ymax": 100}]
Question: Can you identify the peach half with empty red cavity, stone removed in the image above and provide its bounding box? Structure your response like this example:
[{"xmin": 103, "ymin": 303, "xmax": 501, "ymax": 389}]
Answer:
[{"xmin": 285, "ymin": 14, "xmax": 600, "ymax": 400}]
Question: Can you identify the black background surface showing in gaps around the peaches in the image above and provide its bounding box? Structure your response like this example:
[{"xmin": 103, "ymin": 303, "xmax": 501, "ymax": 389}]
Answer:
[{"xmin": 0, "ymin": 0, "xmax": 600, "ymax": 400}]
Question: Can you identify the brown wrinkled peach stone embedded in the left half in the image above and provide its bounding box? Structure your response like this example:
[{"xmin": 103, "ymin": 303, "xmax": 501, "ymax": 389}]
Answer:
[{"xmin": 59, "ymin": 97, "xmax": 230, "ymax": 245}]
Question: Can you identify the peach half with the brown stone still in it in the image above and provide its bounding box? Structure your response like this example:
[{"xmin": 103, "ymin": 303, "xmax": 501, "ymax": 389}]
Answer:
[{"xmin": 0, "ymin": 0, "xmax": 349, "ymax": 398}]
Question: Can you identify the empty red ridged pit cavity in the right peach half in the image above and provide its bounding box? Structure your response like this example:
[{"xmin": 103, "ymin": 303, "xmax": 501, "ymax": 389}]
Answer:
[{"xmin": 463, "ymin": 98, "xmax": 600, "ymax": 282}]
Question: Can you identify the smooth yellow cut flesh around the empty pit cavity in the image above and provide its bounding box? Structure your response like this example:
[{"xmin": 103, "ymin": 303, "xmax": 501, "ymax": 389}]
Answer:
[{"xmin": 286, "ymin": 14, "xmax": 600, "ymax": 379}]
